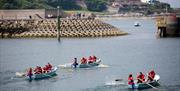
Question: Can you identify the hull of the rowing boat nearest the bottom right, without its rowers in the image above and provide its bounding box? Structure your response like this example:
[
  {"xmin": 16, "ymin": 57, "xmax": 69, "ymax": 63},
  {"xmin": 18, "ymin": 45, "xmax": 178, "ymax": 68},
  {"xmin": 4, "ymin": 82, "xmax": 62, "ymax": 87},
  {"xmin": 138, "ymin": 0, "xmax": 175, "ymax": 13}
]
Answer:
[{"xmin": 128, "ymin": 75, "xmax": 160, "ymax": 89}]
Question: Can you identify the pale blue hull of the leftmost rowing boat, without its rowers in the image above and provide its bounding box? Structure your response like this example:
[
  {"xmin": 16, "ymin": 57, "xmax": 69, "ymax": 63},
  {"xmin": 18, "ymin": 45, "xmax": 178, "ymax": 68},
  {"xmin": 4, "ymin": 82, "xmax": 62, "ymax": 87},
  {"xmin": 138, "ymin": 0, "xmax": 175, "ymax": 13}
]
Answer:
[{"xmin": 27, "ymin": 67, "xmax": 57, "ymax": 80}]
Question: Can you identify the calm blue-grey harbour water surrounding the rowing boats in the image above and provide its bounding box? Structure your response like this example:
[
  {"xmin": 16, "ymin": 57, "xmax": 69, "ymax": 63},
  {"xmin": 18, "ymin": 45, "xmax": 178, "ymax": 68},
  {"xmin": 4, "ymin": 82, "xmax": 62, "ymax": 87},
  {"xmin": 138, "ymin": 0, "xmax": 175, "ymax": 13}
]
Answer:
[{"xmin": 0, "ymin": 19, "xmax": 180, "ymax": 91}]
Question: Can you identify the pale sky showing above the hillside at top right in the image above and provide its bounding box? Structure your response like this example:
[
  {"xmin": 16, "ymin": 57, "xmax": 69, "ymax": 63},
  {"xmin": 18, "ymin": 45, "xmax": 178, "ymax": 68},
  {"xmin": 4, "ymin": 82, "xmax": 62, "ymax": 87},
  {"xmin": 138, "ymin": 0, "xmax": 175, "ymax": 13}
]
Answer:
[{"xmin": 141, "ymin": 0, "xmax": 180, "ymax": 8}]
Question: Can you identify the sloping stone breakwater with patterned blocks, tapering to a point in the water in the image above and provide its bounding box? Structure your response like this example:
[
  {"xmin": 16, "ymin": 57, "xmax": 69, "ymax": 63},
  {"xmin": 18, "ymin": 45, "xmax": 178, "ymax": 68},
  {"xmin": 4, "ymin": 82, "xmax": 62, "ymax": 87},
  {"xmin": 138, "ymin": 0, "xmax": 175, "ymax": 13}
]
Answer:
[{"xmin": 0, "ymin": 18, "xmax": 127, "ymax": 38}]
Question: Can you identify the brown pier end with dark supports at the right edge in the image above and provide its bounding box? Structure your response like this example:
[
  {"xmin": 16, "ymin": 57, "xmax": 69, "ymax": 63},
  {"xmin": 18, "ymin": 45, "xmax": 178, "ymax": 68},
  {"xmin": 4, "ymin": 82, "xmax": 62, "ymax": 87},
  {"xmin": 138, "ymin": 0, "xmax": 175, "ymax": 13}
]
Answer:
[{"xmin": 156, "ymin": 14, "xmax": 180, "ymax": 37}]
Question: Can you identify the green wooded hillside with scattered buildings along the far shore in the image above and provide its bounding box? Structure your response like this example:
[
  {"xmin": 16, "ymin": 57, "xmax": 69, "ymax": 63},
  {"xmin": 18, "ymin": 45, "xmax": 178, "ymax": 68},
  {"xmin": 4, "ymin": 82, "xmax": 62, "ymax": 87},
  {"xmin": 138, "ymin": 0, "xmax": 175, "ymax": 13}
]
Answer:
[{"xmin": 0, "ymin": 0, "xmax": 174, "ymax": 14}]
